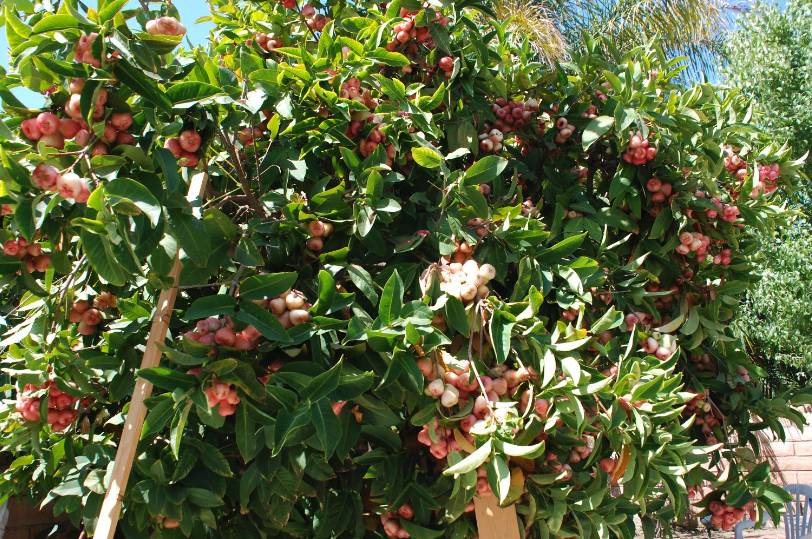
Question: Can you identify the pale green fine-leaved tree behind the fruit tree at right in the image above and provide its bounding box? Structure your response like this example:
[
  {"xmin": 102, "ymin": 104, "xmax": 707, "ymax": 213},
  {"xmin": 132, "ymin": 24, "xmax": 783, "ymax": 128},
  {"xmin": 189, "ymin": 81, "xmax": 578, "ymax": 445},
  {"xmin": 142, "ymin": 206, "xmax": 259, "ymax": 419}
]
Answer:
[{"xmin": 720, "ymin": 0, "xmax": 812, "ymax": 383}]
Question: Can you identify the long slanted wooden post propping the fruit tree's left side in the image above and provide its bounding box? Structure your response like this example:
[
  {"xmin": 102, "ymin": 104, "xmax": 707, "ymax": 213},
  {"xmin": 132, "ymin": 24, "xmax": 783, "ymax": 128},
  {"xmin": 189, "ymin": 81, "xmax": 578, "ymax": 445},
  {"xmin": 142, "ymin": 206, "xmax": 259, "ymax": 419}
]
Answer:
[{"xmin": 94, "ymin": 172, "xmax": 208, "ymax": 539}]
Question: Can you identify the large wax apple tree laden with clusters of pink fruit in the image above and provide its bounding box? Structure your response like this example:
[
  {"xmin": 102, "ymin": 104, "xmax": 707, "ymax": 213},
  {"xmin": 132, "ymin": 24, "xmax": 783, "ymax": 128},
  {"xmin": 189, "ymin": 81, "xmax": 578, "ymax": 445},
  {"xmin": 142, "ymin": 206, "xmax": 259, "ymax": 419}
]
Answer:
[{"xmin": 0, "ymin": 0, "xmax": 806, "ymax": 539}]
